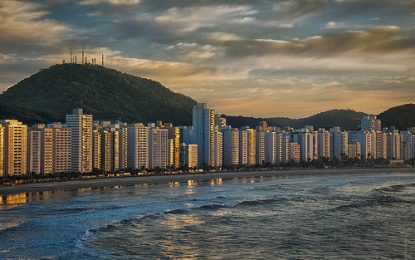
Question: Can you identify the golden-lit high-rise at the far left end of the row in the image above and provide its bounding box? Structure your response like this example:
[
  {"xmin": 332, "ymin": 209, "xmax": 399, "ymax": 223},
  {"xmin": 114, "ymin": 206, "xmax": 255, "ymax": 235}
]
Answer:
[{"xmin": 0, "ymin": 120, "xmax": 28, "ymax": 176}]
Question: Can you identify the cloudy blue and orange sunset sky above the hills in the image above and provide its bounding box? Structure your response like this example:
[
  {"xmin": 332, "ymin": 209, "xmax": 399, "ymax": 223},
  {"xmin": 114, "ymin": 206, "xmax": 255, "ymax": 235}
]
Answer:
[{"xmin": 0, "ymin": 0, "xmax": 415, "ymax": 118}]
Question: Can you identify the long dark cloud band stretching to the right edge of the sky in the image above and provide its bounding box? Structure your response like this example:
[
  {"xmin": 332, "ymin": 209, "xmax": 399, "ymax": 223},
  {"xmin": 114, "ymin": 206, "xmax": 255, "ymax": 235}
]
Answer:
[{"xmin": 225, "ymin": 26, "xmax": 415, "ymax": 57}]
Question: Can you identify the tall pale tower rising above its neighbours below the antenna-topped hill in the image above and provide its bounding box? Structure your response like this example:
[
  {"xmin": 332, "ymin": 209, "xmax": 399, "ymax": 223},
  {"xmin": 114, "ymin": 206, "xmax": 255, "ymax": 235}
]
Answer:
[{"xmin": 66, "ymin": 109, "xmax": 92, "ymax": 173}]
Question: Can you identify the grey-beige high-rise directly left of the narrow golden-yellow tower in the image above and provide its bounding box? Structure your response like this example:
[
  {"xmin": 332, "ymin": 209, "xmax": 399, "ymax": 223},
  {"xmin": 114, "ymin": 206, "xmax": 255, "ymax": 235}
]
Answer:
[{"xmin": 149, "ymin": 127, "xmax": 169, "ymax": 169}]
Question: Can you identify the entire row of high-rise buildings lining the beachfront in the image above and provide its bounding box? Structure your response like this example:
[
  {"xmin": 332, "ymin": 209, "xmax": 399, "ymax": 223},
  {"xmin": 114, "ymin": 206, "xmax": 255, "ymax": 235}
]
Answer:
[{"xmin": 0, "ymin": 103, "xmax": 415, "ymax": 177}]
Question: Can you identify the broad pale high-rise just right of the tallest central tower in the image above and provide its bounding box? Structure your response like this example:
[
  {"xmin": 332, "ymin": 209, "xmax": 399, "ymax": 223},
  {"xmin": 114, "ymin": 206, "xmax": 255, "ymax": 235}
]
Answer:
[{"xmin": 222, "ymin": 127, "xmax": 239, "ymax": 167}]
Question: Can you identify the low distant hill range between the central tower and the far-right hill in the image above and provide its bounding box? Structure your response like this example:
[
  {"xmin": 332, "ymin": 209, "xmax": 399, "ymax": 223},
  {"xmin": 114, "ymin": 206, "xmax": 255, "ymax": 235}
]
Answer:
[{"xmin": 225, "ymin": 109, "xmax": 365, "ymax": 130}]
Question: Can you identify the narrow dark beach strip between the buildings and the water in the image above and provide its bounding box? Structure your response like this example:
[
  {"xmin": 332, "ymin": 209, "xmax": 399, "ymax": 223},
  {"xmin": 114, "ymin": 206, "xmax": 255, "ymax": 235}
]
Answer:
[{"xmin": 0, "ymin": 168, "xmax": 415, "ymax": 196}]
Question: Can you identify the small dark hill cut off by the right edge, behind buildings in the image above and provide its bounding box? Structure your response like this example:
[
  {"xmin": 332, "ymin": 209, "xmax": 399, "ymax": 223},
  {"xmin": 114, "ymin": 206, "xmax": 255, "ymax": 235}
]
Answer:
[{"xmin": 379, "ymin": 104, "xmax": 415, "ymax": 130}]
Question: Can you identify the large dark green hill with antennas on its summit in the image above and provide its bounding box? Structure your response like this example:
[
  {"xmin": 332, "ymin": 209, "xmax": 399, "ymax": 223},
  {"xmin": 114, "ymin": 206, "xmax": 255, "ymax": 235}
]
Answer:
[{"xmin": 0, "ymin": 64, "xmax": 196, "ymax": 124}]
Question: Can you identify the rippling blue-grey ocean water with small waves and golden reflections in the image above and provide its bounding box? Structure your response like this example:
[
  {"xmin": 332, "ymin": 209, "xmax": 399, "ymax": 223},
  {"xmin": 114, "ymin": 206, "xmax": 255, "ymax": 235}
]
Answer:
[{"xmin": 0, "ymin": 173, "xmax": 415, "ymax": 259}]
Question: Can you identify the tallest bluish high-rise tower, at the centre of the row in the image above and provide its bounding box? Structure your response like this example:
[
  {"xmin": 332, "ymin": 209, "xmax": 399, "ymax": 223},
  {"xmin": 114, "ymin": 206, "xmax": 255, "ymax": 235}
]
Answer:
[{"xmin": 192, "ymin": 103, "xmax": 215, "ymax": 167}]
